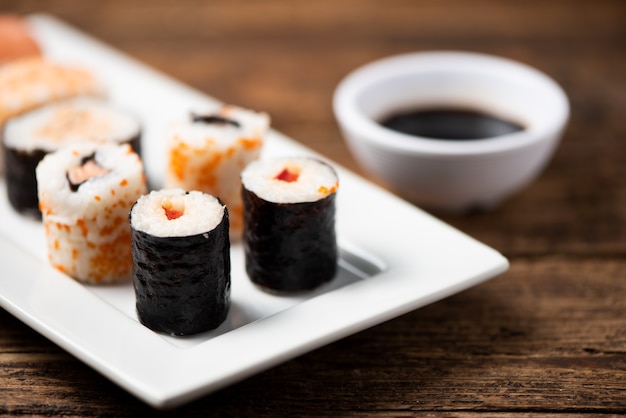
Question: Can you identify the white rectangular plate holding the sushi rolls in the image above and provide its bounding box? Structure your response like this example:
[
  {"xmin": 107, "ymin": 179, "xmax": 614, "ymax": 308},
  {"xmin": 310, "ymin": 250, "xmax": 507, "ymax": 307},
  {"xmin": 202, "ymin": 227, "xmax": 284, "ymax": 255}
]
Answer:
[{"xmin": 0, "ymin": 15, "xmax": 508, "ymax": 408}]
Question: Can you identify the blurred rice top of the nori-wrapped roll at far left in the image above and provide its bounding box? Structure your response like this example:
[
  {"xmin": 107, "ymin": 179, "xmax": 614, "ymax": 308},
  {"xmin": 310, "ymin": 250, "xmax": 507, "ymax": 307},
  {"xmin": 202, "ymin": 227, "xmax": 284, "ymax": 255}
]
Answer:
[{"xmin": 4, "ymin": 96, "xmax": 140, "ymax": 151}]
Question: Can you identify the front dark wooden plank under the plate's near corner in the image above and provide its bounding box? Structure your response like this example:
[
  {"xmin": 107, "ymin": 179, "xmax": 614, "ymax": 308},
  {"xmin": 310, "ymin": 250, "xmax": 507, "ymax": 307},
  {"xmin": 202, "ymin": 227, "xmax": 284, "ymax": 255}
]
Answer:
[{"xmin": 0, "ymin": 257, "xmax": 626, "ymax": 416}]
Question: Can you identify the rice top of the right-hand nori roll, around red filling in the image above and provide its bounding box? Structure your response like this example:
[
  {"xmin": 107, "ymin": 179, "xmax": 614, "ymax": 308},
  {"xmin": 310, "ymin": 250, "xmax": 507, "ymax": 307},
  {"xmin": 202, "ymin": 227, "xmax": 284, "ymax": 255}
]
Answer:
[{"xmin": 241, "ymin": 157, "xmax": 339, "ymax": 203}]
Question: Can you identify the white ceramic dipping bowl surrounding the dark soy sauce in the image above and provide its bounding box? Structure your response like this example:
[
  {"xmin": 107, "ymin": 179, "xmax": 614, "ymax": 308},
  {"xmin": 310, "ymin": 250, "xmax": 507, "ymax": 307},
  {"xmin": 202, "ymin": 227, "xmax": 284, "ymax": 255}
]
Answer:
[{"xmin": 333, "ymin": 51, "xmax": 569, "ymax": 213}]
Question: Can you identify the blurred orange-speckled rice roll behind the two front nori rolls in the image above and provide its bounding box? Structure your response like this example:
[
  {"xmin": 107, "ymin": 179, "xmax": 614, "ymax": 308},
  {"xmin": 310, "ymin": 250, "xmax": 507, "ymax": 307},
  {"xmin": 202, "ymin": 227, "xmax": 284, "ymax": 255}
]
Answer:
[{"xmin": 165, "ymin": 105, "xmax": 270, "ymax": 239}]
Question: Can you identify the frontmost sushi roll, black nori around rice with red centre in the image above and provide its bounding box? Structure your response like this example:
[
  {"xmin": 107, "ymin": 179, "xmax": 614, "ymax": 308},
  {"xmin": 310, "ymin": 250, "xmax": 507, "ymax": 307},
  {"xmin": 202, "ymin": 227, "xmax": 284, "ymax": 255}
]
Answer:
[{"xmin": 130, "ymin": 189, "xmax": 230, "ymax": 335}]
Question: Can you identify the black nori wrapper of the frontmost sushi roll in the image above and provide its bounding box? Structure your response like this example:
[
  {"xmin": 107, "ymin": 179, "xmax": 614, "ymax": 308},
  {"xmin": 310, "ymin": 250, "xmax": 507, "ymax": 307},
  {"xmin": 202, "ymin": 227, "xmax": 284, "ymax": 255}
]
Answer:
[{"xmin": 131, "ymin": 204, "xmax": 231, "ymax": 336}]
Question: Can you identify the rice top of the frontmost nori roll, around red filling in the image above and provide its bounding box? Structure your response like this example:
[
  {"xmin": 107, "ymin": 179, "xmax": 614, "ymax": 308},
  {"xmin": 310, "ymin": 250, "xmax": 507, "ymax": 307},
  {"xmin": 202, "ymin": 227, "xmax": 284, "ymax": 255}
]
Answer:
[{"xmin": 130, "ymin": 189, "xmax": 225, "ymax": 237}]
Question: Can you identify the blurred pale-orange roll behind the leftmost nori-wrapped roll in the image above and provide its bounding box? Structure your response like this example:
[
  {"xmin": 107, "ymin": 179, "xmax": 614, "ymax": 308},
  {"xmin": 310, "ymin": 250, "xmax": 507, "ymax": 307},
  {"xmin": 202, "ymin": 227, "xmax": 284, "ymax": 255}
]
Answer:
[{"xmin": 0, "ymin": 56, "xmax": 105, "ymax": 174}]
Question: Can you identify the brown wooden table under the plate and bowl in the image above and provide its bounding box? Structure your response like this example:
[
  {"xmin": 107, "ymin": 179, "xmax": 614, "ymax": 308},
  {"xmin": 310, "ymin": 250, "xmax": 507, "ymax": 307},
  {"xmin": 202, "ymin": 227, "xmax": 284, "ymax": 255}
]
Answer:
[{"xmin": 0, "ymin": 0, "xmax": 626, "ymax": 417}]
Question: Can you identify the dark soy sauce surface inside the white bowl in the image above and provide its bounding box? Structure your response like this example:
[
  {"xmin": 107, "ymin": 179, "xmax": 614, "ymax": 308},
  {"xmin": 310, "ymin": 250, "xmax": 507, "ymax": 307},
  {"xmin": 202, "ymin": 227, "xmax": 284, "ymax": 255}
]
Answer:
[{"xmin": 380, "ymin": 109, "xmax": 524, "ymax": 140}]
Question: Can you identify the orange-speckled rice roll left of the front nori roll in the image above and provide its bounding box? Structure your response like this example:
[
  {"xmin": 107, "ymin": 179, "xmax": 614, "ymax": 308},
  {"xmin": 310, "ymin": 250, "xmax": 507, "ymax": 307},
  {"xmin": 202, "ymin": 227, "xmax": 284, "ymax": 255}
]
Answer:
[{"xmin": 36, "ymin": 143, "xmax": 147, "ymax": 284}]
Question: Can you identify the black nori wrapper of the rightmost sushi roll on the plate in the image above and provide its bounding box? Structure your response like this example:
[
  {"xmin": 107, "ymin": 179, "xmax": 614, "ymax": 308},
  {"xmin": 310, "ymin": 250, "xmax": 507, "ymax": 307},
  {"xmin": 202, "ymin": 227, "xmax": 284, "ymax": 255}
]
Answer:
[{"xmin": 242, "ymin": 187, "xmax": 338, "ymax": 292}]
